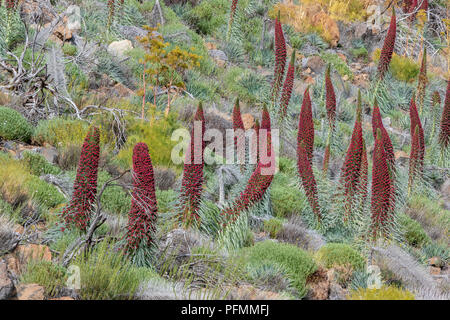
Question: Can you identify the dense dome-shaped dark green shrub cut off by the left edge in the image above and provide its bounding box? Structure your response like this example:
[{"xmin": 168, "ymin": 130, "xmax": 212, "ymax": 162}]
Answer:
[{"xmin": 0, "ymin": 106, "xmax": 33, "ymax": 142}]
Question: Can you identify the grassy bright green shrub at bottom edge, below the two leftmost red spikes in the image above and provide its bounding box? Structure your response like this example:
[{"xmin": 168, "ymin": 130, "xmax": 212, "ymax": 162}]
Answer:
[{"xmin": 74, "ymin": 240, "xmax": 154, "ymax": 300}]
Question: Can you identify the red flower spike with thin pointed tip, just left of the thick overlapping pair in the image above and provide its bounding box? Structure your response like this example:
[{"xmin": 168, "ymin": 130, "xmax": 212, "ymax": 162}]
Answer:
[{"xmin": 340, "ymin": 93, "xmax": 363, "ymax": 215}]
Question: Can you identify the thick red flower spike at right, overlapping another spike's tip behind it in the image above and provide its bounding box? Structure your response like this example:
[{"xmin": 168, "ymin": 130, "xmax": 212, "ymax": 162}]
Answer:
[{"xmin": 371, "ymin": 129, "xmax": 394, "ymax": 240}]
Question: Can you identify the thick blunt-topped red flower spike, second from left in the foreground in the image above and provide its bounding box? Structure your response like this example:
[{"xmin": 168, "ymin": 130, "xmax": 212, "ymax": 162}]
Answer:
[{"xmin": 126, "ymin": 142, "xmax": 158, "ymax": 251}]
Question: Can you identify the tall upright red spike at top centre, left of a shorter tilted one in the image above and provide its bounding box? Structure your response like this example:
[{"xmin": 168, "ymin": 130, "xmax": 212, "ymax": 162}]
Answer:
[{"xmin": 272, "ymin": 11, "xmax": 286, "ymax": 101}]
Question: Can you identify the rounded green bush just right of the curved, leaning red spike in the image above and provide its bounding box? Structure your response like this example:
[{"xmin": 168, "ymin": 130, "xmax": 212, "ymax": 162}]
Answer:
[{"xmin": 270, "ymin": 173, "xmax": 307, "ymax": 218}]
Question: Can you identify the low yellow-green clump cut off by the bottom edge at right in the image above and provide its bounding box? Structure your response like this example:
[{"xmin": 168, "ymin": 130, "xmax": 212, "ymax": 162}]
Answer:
[{"xmin": 347, "ymin": 286, "xmax": 415, "ymax": 300}]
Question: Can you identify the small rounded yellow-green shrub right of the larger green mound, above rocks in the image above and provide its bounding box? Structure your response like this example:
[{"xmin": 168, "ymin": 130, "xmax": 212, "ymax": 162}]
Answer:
[{"xmin": 316, "ymin": 243, "xmax": 366, "ymax": 270}]
